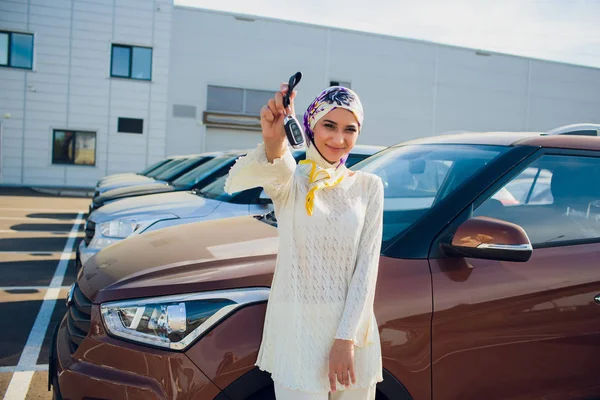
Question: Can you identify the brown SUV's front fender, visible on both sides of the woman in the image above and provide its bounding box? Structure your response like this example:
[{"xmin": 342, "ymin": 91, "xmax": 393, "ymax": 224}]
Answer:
[{"xmin": 186, "ymin": 257, "xmax": 432, "ymax": 399}]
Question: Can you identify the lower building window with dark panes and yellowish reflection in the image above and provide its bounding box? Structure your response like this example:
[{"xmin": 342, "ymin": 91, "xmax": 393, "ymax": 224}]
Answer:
[{"xmin": 52, "ymin": 130, "xmax": 96, "ymax": 166}]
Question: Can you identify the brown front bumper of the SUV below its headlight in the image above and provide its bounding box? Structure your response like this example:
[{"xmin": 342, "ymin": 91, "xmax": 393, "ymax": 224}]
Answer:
[{"xmin": 48, "ymin": 306, "xmax": 221, "ymax": 400}]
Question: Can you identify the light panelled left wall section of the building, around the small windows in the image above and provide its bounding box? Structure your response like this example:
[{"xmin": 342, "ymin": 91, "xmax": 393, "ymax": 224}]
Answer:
[{"xmin": 0, "ymin": 0, "xmax": 173, "ymax": 187}]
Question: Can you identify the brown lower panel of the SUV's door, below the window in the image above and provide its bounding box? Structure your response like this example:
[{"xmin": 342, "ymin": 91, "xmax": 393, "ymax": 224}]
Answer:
[{"xmin": 431, "ymin": 243, "xmax": 600, "ymax": 400}]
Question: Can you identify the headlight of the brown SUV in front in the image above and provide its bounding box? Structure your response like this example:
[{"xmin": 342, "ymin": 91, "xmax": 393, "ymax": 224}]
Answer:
[{"xmin": 100, "ymin": 288, "xmax": 269, "ymax": 350}]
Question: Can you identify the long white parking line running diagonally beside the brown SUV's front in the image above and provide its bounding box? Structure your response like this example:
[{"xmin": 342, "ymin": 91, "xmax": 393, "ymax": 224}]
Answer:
[{"xmin": 4, "ymin": 212, "xmax": 84, "ymax": 400}]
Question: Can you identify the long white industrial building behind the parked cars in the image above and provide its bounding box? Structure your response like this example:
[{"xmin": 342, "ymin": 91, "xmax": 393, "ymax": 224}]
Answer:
[{"xmin": 0, "ymin": 0, "xmax": 600, "ymax": 187}]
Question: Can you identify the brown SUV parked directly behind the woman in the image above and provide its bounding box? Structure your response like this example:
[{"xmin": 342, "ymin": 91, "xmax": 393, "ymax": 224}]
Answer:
[{"xmin": 50, "ymin": 126, "xmax": 600, "ymax": 400}]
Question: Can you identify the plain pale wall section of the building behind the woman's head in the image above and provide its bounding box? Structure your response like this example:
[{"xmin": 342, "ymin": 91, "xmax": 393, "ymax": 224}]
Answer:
[{"xmin": 167, "ymin": 7, "xmax": 600, "ymax": 154}]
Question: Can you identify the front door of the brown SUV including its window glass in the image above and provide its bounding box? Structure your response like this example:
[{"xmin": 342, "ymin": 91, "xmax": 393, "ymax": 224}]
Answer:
[{"xmin": 430, "ymin": 151, "xmax": 600, "ymax": 400}]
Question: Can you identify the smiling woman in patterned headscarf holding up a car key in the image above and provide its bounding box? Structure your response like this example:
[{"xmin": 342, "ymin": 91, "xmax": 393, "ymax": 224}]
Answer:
[{"xmin": 226, "ymin": 84, "xmax": 383, "ymax": 400}]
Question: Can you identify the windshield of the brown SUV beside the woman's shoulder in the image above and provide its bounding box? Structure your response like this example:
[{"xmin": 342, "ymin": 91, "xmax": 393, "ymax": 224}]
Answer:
[{"xmin": 260, "ymin": 144, "xmax": 509, "ymax": 243}]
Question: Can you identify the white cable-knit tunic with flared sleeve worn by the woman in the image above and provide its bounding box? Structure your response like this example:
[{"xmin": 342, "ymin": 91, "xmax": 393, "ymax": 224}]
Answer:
[{"xmin": 226, "ymin": 144, "xmax": 383, "ymax": 393}]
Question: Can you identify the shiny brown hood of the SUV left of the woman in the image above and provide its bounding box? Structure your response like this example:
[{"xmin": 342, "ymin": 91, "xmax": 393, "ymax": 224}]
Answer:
[{"xmin": 77, "ymin": 216, "xmax": 278, "ymax": 303}]
